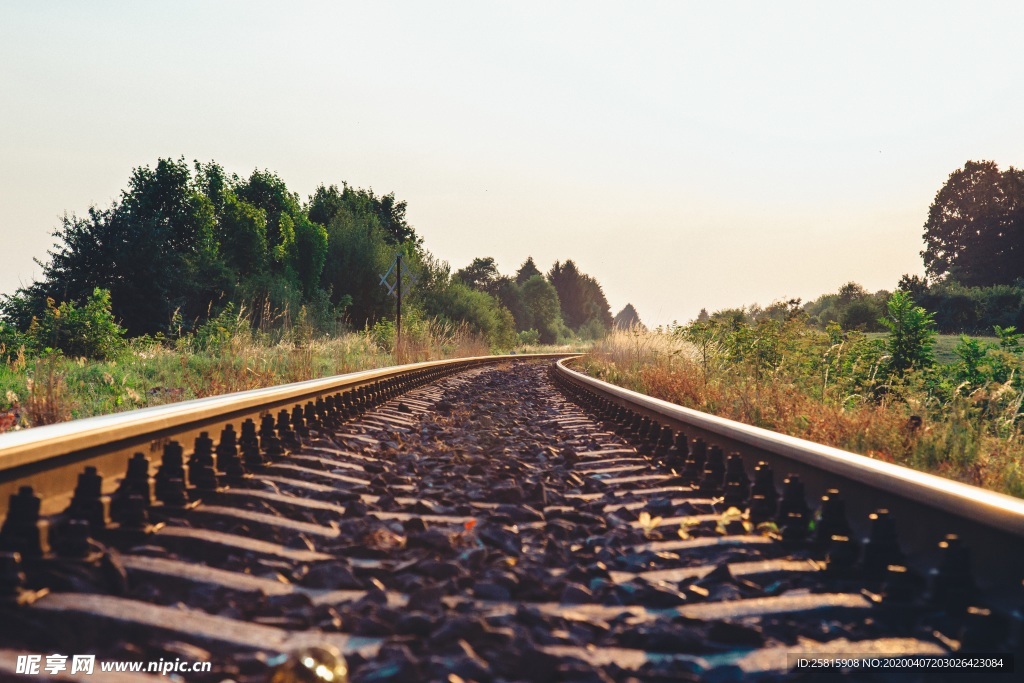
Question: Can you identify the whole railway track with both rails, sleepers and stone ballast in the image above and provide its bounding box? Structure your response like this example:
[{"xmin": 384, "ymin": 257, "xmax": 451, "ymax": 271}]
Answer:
[{"xmin": 0, "ymin": 356, "xmax": 1024, "ymax": 683}]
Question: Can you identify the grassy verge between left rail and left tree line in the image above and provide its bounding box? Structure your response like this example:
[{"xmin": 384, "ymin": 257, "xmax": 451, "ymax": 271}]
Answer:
[{"xmin": 0, "ymin": 313, "xmax": 581, "ymax": 431}]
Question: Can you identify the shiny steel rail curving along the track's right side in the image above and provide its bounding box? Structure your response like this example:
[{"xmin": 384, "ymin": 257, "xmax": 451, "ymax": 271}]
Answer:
[{"xmin": 556, "ymin": 358, "xmax": 1024, "ymax": 592}]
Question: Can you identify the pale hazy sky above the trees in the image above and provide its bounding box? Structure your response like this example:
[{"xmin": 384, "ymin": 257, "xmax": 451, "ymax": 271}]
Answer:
[{"xmin": 0, "ymin": 0, "xmax": 1024, "ymax": 325}]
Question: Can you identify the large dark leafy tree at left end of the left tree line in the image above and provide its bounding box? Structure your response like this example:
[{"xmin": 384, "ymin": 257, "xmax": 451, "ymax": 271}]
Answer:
[{"xmin": 23, "ymin": 159, "xmax": 224, "ymax": 335}]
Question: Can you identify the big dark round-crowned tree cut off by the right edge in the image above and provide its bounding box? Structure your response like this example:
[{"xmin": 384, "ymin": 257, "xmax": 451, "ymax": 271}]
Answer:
[{"xmin": 921, "ymin": 161, "xmax": 1024, "ymax": 286}]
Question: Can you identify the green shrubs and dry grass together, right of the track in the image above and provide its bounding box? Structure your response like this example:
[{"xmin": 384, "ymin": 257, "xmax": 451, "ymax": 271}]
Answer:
[{"xmin": 580, "ymin": 323, "xmax": 1024, "ymax": 497}]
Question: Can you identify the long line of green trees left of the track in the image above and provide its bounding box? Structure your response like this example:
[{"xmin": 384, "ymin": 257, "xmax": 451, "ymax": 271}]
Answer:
[{"xmin": 0, "ymin": 159, "xmax": 630, "ymax": 356}]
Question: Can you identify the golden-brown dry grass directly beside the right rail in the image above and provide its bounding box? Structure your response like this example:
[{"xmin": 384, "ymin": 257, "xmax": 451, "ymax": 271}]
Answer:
[{"xmin": 584, "ymin": 331, "xmax": 1024, "ymax": 497}]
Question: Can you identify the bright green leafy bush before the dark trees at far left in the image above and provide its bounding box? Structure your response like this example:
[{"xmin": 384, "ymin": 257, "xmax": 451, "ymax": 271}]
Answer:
[{"xmin": 27, "ymin": 288, "xmax": 125, "ymax": 359}]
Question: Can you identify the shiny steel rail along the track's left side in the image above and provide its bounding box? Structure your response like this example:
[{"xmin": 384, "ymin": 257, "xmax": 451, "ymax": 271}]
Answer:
[{"xmin": 0, "ymin": 353, "xmax": 573, "ymax": 517}]
